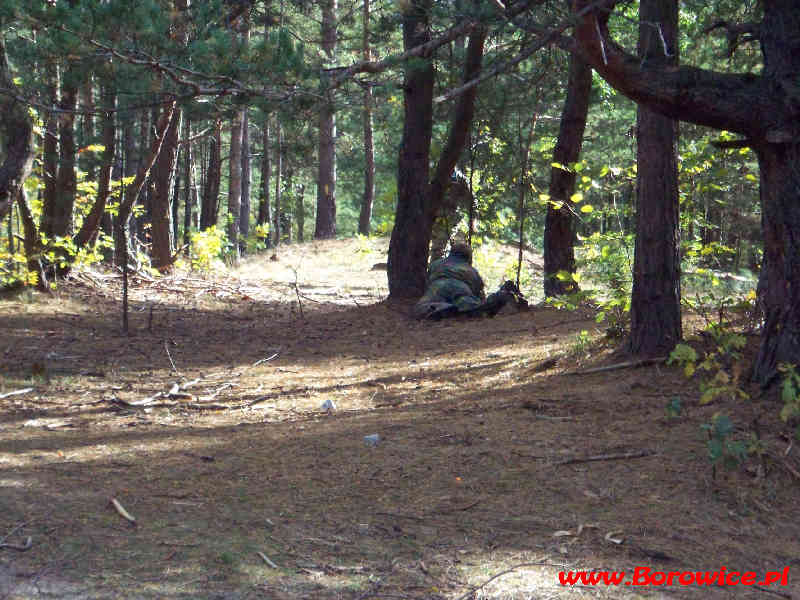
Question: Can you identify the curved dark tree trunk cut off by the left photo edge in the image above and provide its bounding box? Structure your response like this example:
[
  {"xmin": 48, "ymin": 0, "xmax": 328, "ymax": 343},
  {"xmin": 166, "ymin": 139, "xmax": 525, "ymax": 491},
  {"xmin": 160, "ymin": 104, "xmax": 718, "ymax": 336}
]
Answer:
[{"xmin": 0, "ymin": 31, "xmax": 34, "ymax": 219}]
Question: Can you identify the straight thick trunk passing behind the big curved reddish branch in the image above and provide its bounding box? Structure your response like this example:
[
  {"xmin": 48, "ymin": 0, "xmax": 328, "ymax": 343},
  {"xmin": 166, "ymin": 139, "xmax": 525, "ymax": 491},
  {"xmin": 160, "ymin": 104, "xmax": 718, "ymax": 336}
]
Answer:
[{"xmin": 628, "ymin": 0, "xmax": 682, "ymax": 357}]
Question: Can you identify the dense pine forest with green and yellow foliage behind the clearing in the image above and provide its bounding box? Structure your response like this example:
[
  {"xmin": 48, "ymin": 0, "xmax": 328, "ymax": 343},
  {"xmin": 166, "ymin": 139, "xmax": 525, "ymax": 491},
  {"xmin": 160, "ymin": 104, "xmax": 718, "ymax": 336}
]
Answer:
[{"xmin": 0, "ymin": 0, "xmax": 800, "ymax": 382}]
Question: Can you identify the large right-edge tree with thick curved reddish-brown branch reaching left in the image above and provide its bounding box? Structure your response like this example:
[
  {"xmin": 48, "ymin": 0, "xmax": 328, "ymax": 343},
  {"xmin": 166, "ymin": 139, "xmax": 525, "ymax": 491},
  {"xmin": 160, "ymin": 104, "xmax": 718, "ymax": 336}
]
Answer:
[{"xmin": 573, "ymin": 0, "xmax": 800, "ymax": 385}]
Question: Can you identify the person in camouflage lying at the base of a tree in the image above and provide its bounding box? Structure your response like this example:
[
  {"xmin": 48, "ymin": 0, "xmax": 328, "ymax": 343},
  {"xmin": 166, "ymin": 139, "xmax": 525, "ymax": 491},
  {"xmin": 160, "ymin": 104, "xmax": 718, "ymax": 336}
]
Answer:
[{"xmin": 414, "ymin": 243, "xmax": 485, "ymax": 319}]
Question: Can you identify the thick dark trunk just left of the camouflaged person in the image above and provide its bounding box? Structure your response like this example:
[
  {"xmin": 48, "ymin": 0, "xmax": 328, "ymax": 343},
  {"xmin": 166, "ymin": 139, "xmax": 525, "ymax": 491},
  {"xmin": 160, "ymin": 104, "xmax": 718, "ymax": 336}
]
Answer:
[{"xmin": 387, "ymin": 0, "xmax": 434, "ymax": 298}]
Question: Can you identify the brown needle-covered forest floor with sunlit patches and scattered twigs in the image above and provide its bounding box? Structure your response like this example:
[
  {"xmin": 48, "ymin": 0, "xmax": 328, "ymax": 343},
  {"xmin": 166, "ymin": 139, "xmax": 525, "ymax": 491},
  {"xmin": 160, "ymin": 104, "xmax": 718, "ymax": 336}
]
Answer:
[{"xmin": 0, "ymin": 239, "xmax": 800, "ymax": 600}]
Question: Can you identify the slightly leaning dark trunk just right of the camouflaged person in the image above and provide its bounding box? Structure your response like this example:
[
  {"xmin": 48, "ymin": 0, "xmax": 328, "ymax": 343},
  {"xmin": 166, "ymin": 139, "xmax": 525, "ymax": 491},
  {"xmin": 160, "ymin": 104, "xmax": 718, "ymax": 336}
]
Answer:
[{"xmin": 544, "ymin": 54, "xmax": 592, "ymax": 297}]
